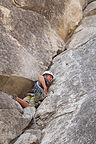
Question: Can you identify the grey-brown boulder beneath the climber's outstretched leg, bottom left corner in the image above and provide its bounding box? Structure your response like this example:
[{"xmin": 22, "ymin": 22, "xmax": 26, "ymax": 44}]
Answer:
[{"xmin": 0, "ymin": 92, "xmax": 33, "ymax": 144}]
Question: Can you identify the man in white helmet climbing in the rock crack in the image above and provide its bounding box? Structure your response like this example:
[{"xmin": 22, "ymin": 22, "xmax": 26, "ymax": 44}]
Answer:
[{"xmin": 13, "ymin": 71, "xmax": 54, "ymax": 108}]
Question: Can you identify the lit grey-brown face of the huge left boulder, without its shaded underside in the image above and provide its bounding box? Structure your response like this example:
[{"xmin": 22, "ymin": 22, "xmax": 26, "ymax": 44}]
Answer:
[{"xmin": 0, "ymin": 2, "xmax": 63, "ymax": 80}]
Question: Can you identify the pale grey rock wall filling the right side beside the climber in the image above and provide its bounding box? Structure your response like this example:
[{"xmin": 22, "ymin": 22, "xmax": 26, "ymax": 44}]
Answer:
[{"xmin": 37, "ymin": 1, "xmax": 96, "ymax": 144}]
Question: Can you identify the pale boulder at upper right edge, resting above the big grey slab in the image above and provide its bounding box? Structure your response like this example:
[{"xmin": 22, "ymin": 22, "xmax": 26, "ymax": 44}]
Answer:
[{"xmin": 68, "ymin": 2, "xmax": 96, "ymax": 49}]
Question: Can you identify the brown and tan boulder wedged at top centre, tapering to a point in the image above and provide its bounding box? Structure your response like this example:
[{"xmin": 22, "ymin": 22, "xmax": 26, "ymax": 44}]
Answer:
[{"xmin": 10, "ymin": 0, "xmax": 82, "ymax": 40}]
